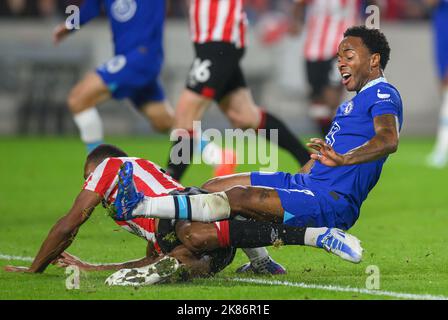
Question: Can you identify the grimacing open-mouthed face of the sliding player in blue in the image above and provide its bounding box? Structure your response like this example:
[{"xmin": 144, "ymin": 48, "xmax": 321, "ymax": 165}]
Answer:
[{"xmin": 337, "ymin": 37, "xmax": 381, "ymax": 91}]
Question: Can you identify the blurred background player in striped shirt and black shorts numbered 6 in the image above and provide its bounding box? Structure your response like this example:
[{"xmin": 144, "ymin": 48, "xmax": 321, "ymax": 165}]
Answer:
[{"xmin": 168, "ymin": 0, "xmax": 309, "ymax": 180}]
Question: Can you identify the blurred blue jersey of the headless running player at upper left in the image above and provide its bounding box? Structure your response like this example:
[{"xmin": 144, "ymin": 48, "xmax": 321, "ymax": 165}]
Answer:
[{"xmin": 80, "ymin": 0, "xmax": 166, "ymax": 55}]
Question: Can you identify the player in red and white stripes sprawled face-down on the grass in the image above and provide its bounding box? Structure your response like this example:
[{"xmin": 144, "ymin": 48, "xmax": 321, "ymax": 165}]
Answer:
[{"xmin": 7, "ymin": 145, "xmax": 360, "ymax": 278}]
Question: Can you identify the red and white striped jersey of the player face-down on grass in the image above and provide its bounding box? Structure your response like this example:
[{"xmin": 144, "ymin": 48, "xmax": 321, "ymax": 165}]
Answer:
[{"xmin": 83, "ymin": 158, "xmax": 184, "ymax": 248}]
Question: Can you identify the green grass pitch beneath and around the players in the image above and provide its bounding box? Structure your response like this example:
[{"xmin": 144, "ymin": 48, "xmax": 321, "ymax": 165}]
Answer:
[{"xmin": 0, "ymin": 137, "xmax": 448, "ymax": 299}]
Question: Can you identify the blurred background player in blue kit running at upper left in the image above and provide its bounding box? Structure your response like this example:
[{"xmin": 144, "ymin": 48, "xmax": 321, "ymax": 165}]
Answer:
[{"xmin": 54, "ymin": 0, "xmax": 174, "ymax": 152}]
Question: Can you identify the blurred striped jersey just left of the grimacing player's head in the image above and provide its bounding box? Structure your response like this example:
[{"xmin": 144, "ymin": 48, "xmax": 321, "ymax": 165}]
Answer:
[{"xmin": 296, "ymin": 0, "xmax": 362, "ymax": 61}]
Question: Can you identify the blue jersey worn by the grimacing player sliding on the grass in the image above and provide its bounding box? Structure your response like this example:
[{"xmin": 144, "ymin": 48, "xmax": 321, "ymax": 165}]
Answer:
[{"xmin": 303, "ymin": 78, "xmax": 403, "ymax": 212}]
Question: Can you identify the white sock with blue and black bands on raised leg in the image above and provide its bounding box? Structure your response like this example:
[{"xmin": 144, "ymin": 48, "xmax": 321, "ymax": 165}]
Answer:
[{"xmin": 132, "ymin": 192, "xmax": 230, "ymax": 222}]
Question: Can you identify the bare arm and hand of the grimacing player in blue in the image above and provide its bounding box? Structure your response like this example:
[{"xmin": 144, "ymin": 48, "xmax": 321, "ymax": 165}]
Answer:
[{"xmin": 307, "ymin": 114, "xmax": 399, "ymax": 167}]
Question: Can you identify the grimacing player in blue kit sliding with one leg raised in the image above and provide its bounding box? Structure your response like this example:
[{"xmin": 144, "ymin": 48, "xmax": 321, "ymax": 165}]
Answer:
[{"xmin": 112, "ymin": 27, "xmax": 403, "ymax": 245}]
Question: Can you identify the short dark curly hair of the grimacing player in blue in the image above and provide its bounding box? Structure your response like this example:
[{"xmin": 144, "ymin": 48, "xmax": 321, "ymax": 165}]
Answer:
[{"xmin": 344, "ymin": 26, "xmax": 390, "ymax": 70}]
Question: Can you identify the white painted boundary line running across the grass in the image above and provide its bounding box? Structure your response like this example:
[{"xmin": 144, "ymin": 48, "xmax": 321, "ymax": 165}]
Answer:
[{"xmin": 0, "ymin": 253, "xmax": 448, "ymax": 300}]
